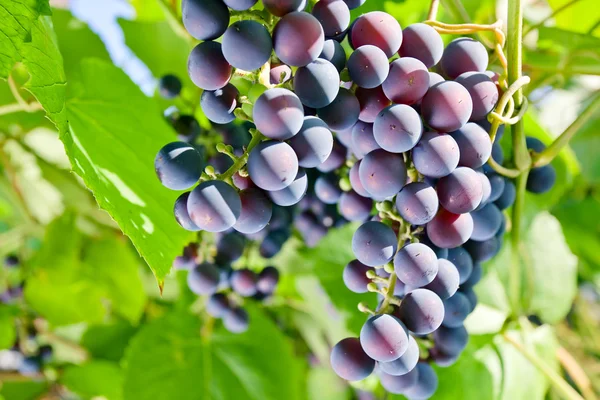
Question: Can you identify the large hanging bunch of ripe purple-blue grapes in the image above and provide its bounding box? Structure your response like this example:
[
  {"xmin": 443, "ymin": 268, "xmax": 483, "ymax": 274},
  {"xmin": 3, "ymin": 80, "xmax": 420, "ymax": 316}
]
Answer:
[{"xmin": 155, "ymin": 0, "xmax": 556, "ymax": 399}]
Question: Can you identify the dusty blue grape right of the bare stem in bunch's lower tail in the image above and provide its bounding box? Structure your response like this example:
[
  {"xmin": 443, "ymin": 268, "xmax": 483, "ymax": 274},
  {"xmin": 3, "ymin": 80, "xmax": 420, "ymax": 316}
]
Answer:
[{"xmin": 394, "ymin": 243, "xmax": 438, "ymax": 287}]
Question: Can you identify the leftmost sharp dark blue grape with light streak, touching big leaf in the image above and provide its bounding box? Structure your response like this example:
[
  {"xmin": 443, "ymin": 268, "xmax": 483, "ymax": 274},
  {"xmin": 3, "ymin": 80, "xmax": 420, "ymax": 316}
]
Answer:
[{"xmin": 154, "ymin": 142, "xmax": 202, "ymax": 190}]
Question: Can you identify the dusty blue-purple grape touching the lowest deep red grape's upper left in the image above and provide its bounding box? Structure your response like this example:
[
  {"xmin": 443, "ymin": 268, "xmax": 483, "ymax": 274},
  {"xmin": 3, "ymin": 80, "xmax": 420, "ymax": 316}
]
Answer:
[{"xmin": 396, "ymin": 182, "xmax": 438, "ymax": 225}]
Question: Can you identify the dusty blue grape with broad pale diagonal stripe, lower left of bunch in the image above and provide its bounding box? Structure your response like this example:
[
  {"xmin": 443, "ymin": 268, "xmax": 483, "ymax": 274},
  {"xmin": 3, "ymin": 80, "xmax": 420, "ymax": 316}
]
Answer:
[{"xmin": 188, "ymin": 180, "xmax": 242, "ymax": 232}]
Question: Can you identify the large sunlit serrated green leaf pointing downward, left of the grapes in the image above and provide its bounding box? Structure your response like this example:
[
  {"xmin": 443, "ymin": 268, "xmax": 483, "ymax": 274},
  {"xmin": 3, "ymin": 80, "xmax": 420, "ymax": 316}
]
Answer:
[{"xmin": 61, "ymin": 60, "xmax": 194, "ymax": 284}]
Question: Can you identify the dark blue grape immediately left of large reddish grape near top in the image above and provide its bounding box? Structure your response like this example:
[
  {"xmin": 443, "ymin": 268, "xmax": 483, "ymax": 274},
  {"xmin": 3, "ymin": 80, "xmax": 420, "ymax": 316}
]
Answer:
[{"xmin": 222, "ymin": 20, "xmax": 273, "ymax": 71}]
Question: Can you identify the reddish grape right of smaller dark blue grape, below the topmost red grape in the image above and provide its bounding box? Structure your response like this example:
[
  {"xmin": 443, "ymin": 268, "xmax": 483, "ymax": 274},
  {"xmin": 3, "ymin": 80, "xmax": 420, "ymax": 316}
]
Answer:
[{"xmin": 382, "ymin": 57, "xmax": 429, "ymax": 105}]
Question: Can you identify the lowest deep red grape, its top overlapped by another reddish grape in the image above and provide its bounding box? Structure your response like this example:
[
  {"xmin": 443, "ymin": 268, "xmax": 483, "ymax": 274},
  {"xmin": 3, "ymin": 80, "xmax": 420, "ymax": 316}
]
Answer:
[{"xmin": 426, "ymin": 208, "xmax": 473, "ymax": 249}]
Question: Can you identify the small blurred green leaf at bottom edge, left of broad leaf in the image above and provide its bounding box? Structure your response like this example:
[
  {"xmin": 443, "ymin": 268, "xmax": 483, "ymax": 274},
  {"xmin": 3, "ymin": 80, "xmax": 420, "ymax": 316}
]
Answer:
[{"xmin": 60, "ymin": 361, "xmax": 123, "ymax": 400}]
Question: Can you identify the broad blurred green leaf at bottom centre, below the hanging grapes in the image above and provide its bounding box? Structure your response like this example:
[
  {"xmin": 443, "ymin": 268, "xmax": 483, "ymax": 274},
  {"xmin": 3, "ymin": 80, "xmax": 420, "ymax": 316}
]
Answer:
[{"xmin": 124, "ymin": 309, "xmax": 305, "ymax": 400}]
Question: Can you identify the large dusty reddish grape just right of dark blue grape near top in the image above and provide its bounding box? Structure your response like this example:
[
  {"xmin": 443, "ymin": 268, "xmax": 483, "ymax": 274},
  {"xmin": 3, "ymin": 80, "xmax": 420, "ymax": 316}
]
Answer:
[{"xmin": 273, "ymin": 12, "xmax": 325, "ymax": 67}]
